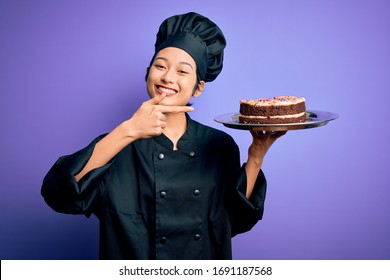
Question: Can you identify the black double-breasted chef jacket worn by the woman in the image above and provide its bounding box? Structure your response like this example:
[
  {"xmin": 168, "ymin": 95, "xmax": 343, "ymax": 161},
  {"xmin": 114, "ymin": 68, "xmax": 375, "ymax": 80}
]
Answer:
[{"xmin": 42, "ymin": 115, "xmax": 266, "ymax": 259}]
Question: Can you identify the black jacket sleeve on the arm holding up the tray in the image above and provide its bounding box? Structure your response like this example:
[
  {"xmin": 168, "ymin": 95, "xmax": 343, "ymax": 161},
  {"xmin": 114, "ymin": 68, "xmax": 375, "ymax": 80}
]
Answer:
[{"xmin": 226, "ymin": 138, "xmax": 267, "ymax": 236}]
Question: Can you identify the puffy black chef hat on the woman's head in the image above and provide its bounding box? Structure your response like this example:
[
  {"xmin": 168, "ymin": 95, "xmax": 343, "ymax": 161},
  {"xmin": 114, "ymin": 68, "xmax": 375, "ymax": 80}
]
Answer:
[{"xmin": 151, "ymin": 12, "xmax": 226, "ymax": 82}]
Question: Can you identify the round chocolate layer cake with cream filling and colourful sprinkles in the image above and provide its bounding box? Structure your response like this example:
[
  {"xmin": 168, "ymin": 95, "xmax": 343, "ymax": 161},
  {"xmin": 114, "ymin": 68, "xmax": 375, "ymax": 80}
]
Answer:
[{"xmin": 238, "ymin": 96, "xmax": 306, "ymax": 124}]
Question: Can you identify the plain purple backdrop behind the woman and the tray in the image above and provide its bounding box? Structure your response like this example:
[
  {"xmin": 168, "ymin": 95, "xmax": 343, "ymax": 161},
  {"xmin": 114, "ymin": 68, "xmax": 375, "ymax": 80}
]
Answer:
[{"xmin": 0, "ymin": 0, "xmax": 390, "ymax": 259}]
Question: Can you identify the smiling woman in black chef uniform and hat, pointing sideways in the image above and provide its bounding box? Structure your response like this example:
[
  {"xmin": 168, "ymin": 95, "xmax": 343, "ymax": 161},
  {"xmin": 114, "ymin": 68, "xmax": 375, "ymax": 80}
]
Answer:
[{"xmin": 42, "ymin": 13, "xmax": 284, "ymax": 259}]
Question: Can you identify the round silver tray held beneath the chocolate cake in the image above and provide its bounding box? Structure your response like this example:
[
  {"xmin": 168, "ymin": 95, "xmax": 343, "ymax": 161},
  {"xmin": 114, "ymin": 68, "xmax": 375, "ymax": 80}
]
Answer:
[{"xmin": 214, "ymin": 110, "xmax": 339, "ymax": 131}]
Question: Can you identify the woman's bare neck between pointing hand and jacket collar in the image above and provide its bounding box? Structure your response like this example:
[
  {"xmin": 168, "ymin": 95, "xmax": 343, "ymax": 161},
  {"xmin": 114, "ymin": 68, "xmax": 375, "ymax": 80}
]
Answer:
[{"xmin": 163, "ymin": 113, "xmax": 187, "ymax": 150}]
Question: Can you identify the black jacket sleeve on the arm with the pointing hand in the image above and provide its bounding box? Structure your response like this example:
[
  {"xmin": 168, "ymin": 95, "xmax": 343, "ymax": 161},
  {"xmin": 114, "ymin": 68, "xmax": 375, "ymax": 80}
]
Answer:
[{"xmin": 41, "ymin": 135, "xmax": 113, "ymax": 216}]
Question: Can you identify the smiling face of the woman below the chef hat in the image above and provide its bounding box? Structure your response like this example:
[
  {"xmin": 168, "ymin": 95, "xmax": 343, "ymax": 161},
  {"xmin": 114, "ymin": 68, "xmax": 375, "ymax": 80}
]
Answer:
[{"xmin": 146, "ymin": 47, "xmax": 204, "ymax": 106}]
